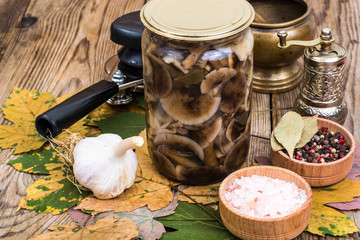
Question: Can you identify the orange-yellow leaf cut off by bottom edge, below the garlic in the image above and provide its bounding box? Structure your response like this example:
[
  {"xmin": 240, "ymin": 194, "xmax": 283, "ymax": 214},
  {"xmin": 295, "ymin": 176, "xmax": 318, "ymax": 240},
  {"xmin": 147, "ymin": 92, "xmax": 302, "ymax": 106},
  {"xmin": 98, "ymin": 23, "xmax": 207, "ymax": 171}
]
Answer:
[{"xmin": 31, "ymin": 217, "xmax": 139, "ymax": 240}]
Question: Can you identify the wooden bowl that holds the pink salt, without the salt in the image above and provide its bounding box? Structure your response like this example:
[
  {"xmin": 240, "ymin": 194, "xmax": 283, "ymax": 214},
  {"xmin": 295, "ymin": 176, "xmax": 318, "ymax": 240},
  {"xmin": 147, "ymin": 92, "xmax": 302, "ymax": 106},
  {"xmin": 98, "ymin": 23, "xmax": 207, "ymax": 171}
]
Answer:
[{"xmin": 219, "ymin": 166, "xmax": 312, "ymax": 240}]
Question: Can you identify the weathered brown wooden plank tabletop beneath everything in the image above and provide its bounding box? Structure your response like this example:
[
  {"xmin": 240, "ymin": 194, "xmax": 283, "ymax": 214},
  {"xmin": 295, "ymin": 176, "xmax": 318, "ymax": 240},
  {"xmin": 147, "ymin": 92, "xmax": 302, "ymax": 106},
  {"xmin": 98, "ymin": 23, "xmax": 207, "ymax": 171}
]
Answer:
[{"xmin": 0, "ymin": 0, "xmax": 360, "ymax": 239}]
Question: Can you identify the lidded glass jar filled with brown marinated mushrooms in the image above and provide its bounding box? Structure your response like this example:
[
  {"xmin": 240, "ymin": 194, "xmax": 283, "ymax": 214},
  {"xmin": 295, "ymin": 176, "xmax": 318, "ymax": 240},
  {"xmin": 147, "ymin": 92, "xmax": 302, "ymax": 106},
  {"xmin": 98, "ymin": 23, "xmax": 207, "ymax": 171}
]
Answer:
[{"xmin": 140, "ymin": 0, "xmax": 255, "ymax": 185}]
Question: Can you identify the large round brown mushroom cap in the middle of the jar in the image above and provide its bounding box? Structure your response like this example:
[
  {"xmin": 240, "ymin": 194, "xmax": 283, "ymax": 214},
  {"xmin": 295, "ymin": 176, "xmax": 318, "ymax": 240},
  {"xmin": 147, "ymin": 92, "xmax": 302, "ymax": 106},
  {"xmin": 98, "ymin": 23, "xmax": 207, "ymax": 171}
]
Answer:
[{"xmin": 160, "ymin": 85, "xmax": 221, "ymax": 125}]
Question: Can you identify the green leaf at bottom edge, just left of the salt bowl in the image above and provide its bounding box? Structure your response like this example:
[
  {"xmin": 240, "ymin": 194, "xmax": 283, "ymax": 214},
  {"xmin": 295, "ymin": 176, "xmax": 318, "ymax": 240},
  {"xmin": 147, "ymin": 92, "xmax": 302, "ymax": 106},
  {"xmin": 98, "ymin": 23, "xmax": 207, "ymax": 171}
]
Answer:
[{"xmin": 158, "ymin": 201, "xmax": 235, "ymax": 240}]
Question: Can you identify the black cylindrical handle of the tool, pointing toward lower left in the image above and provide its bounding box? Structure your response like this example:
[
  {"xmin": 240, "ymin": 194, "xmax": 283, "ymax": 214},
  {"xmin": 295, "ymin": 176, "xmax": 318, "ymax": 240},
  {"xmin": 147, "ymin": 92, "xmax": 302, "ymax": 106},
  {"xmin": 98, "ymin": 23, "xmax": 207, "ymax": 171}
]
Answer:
[{"xmin": 35, "ymin": 80, "xmax": 118, "ymax": 138}]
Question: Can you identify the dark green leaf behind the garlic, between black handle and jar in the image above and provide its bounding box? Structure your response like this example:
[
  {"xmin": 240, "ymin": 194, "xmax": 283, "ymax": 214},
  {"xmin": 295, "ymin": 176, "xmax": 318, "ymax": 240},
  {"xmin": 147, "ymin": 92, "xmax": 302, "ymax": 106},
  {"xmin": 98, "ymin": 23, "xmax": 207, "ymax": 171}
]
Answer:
[{"xmin": 96, "ymin": 112, "xmax": 146, "ymax": 139}]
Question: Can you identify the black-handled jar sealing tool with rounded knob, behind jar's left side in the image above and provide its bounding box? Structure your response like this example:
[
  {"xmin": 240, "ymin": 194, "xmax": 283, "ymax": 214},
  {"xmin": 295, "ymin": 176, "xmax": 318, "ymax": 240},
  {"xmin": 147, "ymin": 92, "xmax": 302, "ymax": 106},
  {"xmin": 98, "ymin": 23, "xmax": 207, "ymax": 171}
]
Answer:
[{"xmin": 35, "ymin": 11, "xmax": 144, "ymax": 138}]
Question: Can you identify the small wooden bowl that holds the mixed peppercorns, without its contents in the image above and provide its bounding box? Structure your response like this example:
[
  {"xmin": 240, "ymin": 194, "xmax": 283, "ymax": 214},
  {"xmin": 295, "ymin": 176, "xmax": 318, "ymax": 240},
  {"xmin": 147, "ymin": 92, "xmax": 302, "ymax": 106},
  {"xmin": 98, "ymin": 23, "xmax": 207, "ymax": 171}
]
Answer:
[{"xmin": 271, "ymin": 118, "xmax": 356, "ymax": 187}]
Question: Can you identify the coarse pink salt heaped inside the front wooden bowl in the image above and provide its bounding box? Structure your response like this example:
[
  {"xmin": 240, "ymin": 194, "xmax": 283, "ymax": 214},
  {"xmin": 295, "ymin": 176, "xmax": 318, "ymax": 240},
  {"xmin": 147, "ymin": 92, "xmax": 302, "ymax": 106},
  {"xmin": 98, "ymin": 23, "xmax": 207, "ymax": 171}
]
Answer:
[{"xmin": 225, "ymin": 175, "xmax": 307, "ymax": 218}]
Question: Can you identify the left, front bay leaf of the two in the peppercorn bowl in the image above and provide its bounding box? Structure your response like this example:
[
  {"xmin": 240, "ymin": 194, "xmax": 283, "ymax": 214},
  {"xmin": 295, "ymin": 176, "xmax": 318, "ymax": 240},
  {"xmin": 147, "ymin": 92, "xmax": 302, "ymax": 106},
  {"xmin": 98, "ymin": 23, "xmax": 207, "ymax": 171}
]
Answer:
[{"xmin": 274, "ymin": 112, "xmax": 304, "ymax": 157}]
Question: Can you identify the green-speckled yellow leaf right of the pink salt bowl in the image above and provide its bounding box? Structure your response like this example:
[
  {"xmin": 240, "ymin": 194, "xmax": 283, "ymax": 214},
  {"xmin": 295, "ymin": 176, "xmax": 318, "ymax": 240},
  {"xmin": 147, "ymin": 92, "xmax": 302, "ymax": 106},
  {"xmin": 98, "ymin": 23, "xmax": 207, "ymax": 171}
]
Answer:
[{"xmin": 306, "ymin": 178, "xmax": 360, "ymax": 236}]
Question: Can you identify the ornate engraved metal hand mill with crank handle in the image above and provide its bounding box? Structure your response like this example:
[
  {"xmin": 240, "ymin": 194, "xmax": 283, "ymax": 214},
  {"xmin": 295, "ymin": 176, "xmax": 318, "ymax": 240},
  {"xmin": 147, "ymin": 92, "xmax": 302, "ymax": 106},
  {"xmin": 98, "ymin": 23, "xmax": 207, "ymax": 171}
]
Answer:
[{"xmin": 278, "ymin": 28, "xmax": 347, "ymax": 124}]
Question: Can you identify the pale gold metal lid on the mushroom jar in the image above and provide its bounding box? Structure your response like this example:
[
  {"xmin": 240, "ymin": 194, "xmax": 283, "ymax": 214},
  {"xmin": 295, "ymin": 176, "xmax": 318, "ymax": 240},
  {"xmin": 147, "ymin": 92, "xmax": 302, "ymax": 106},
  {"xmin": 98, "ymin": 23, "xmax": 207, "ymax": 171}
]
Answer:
[{"xmin": 140, "ymin": 0, "xmax": 255, "ymax": 41}]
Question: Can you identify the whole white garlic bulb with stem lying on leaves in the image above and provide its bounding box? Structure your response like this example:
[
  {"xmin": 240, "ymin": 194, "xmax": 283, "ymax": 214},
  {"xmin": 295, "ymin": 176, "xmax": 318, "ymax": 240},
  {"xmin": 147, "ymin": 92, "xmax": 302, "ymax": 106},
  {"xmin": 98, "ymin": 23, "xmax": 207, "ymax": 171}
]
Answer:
[{"xmin": 73, "ymin": 133, "xmax": 144, "ymax": 199}]
